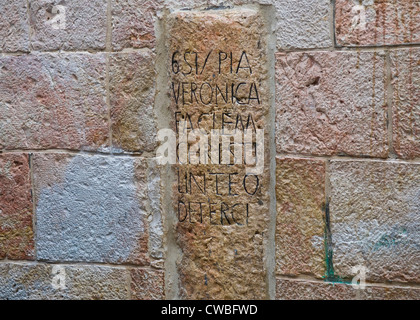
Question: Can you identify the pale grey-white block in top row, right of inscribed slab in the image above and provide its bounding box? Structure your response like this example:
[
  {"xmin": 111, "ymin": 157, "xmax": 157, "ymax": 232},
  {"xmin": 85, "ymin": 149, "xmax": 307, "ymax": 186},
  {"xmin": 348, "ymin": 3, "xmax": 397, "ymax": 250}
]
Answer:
[{"xmin": 273, "ymin": 0, "xmax": 333, "ymax": 49}]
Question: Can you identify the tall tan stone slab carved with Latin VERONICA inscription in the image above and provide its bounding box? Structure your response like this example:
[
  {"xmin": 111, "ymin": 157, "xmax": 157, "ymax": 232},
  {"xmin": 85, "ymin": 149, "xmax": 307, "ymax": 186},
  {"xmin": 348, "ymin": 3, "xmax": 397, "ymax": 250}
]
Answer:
[{"xmin": 167, "ymin": 9, "xmax": 272, "ymax": 299}]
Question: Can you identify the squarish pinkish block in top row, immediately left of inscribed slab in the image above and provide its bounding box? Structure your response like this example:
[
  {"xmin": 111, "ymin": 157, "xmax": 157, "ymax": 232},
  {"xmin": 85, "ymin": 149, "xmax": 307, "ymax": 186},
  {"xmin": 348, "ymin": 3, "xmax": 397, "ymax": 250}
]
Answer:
[{"xmin": 112, "ymin": 0, "xmax": 161, "ymax": 50}]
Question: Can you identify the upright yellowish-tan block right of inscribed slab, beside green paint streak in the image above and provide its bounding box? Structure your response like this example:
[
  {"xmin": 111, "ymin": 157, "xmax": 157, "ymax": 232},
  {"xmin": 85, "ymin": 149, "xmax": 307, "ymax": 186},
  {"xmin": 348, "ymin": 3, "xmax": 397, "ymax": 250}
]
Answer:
[{"xmin": 276, "ymin": 158, "xmax": 325, "ymax": 278}]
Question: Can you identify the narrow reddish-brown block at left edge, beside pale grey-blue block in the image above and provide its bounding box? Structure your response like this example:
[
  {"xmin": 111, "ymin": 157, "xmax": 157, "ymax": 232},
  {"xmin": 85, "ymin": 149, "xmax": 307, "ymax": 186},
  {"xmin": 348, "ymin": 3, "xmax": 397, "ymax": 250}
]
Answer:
[{"xmin": 0, "ymin": 154, "xmax": 34, "ymax": 260}]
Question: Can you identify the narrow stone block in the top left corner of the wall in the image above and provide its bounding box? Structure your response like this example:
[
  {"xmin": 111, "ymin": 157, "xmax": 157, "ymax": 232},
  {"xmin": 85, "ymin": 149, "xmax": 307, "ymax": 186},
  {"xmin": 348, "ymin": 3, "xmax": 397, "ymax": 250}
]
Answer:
[{"xmin": 0, "ymin": 0, "xmax": 29, "ymax": 52}]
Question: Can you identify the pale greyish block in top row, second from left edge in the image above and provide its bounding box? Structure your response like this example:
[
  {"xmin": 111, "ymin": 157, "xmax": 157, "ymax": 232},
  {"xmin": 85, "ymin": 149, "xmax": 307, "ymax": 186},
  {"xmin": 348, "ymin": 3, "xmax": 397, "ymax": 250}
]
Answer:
[{"xmin": 30, "ymin": 0, "xmax": 107, "ymax": 51}]
